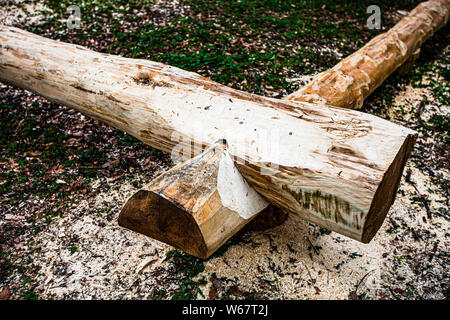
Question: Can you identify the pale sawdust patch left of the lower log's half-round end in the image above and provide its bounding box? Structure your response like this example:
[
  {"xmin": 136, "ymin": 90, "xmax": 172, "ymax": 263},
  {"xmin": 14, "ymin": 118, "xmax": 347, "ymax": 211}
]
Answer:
[{"xmin": 33, "ymin": 171, "xmax": 176, "ymax": 299}]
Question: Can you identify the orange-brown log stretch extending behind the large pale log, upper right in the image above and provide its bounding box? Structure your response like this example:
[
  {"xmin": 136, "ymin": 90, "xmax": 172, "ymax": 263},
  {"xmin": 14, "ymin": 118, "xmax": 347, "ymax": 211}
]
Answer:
[{"xmin": 287, "ymin": 0, "xmax": 450, "ymax": 109}]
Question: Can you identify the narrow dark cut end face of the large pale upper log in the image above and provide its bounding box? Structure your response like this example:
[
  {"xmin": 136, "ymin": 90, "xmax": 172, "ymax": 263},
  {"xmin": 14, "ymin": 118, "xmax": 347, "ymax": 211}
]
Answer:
[{"xmin": 361, "ymin": 133, "xmax": 417, "ymax": 243}]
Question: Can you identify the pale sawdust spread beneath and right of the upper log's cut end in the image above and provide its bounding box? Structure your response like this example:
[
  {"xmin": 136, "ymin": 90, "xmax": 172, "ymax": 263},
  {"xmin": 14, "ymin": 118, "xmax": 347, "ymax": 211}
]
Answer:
[{"xmin": 199, "ymin": 166, "xmax": 450, "ymax": 299}]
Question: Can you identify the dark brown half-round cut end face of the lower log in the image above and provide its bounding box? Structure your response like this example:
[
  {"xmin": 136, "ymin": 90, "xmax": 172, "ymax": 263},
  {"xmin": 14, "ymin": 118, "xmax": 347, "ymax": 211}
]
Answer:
[{"xmin": 119, "ymin": 190, "xmax": 208, "ymax": 259}]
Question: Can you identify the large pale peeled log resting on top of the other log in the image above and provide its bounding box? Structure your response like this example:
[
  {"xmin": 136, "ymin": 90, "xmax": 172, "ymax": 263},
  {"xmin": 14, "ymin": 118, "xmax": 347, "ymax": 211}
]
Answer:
[{"xmin": 0, "ymin": 27, "xmax": 415, "ymax": 242}]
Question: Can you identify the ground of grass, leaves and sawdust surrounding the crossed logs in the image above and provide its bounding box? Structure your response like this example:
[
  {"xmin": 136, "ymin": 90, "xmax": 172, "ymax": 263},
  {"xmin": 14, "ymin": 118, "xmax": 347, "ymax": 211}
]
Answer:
[{"xmin": 0, "ymin": 0, "xmax": 450, "ymax": 299}]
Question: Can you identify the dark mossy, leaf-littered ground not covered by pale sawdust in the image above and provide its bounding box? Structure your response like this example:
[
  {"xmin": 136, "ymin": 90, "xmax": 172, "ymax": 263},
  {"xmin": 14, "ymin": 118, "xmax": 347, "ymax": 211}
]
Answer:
[{"xmin": 0, "ymin": 0, "xmax": 450, "ymax": 299}]
